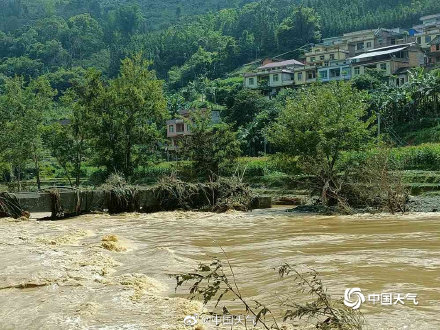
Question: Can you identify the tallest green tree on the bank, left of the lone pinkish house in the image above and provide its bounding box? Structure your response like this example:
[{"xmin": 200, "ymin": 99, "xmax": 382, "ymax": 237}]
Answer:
[{"xmin": 90, "ymin": 54, "xmax": 167, "ymax": 177}]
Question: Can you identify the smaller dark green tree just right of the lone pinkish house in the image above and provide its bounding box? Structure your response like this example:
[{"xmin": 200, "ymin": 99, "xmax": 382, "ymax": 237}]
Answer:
[{"xmin": 179, "ymin": 110, "xmax": 240, "ymax": 180}]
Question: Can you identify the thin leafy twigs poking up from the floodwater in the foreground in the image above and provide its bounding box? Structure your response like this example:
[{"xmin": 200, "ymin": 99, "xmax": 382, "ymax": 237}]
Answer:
[{"xmin": 173, "ymin": 251, "xmax": 364, "ymax": 330}]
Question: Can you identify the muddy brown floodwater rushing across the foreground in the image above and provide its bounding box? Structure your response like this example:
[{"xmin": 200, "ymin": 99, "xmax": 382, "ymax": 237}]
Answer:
[{"xmin": 0, "ymin": 209, "xmax": 440, "ymax": 329}]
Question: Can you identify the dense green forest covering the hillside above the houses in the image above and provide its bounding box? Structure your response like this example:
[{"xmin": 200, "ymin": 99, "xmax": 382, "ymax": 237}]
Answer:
[{"xmin": 0, "ymin": 0, "xmax": 440, "ymax": 91}]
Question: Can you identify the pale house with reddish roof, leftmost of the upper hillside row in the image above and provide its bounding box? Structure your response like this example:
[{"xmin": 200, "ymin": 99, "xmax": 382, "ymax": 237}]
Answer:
[{"xmin": 244, "ymin": 59, "xmax": 304, "ymax": 92}]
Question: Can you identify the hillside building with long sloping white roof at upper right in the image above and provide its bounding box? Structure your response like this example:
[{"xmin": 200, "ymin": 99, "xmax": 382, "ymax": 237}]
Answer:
[{"xmin": 349, "ymin": 43, "xmax": 424, "ymax": 85}]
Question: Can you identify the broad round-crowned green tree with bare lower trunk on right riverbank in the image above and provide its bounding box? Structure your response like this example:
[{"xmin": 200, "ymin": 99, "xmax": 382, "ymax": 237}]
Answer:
[{"xmin": 268, "ymin": 82, "xmax": 372, "ymax": 205}]
